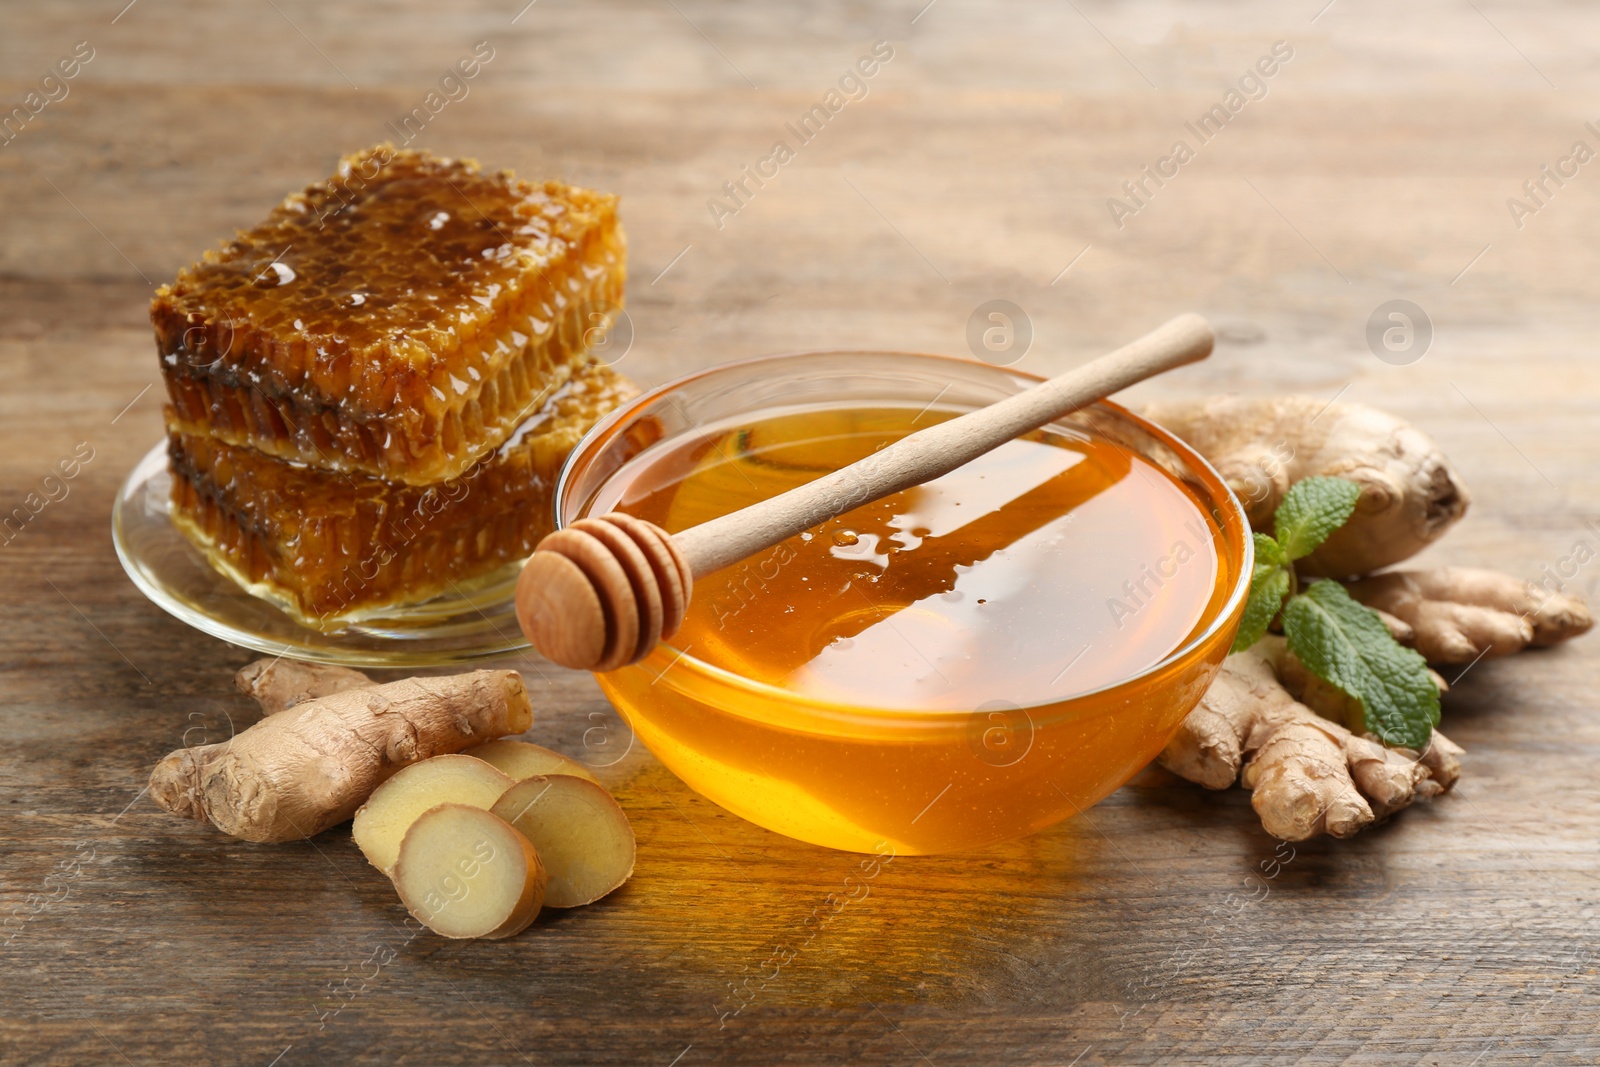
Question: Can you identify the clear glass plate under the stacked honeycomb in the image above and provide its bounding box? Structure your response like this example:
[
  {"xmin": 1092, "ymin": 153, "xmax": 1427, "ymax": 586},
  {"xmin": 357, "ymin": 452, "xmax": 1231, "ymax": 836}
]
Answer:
[{"xmin": 110, "ymin": 442, "xmax": 528, "ymax": 667}]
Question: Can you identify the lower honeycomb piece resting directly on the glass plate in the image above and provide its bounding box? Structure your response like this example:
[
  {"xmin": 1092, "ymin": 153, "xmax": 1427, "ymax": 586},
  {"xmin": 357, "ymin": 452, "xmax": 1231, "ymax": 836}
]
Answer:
[{"xmin": 168, "ymin": 365, "xmax": 638, "ymax": 630}]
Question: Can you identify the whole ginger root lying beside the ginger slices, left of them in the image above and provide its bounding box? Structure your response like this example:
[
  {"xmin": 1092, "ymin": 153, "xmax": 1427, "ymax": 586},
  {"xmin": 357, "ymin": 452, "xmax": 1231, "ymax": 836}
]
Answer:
[{"xmin": 150, "ymin": 670, "xmax": 533, "ymax": 841}]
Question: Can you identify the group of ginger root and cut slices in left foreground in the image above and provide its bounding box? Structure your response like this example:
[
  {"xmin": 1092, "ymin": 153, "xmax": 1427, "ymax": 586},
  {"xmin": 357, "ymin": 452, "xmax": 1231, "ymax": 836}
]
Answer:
[{"xmin": 150, "ymin": 659, "xmax": 634, "ymax": 937}]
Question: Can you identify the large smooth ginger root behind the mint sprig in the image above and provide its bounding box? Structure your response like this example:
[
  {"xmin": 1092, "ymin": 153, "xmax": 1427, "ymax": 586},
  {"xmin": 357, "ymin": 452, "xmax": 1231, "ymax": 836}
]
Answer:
[{"xmin": 1142, "ymin": 397, "xmax": 1470, "ymax": 577}]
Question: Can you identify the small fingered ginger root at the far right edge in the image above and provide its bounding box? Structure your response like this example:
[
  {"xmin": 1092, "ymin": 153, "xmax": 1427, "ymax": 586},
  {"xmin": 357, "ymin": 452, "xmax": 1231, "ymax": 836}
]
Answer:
[{"xmin": 1346, "ymin": 566, "xmax": 1594, "ymax": 664}]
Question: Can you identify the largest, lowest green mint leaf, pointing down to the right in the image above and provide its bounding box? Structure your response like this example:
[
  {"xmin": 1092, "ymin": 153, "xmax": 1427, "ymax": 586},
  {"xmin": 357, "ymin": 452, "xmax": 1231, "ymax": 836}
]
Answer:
[{"xmin": 1283, "ymin": 582, "xmax": 1438, "ymax": 752}]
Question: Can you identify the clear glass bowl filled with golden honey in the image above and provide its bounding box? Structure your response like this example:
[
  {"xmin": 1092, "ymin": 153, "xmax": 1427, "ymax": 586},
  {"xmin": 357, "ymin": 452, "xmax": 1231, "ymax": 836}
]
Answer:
[{"xmin": 555, "ymin": 352, "xmax": 1253, "ymax": 854}]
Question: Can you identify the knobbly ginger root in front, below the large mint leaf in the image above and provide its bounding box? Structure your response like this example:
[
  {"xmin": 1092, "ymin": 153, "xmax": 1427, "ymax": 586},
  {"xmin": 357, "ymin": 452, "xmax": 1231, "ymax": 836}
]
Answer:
[{"xmin": 1158, "ymin": 637, "xmax": 1461, "ymax": 841}]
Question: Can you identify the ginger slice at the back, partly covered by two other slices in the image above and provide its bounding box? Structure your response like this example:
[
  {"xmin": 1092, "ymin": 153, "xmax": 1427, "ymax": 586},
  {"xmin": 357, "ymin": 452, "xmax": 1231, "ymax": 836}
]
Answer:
[{"xmin": 350, "ymin": 753, "xmax": 515, "ymax": 873}]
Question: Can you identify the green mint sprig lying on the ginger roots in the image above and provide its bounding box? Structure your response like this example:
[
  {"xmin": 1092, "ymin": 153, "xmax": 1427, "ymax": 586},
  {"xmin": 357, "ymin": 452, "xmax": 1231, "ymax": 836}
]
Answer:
[{"xmin": 1234, "ymin": 477, "xmax": 1438, "ymax": 750}]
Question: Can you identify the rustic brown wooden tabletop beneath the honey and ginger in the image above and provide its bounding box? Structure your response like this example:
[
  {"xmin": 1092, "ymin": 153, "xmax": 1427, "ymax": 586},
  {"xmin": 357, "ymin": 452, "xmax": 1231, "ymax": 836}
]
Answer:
[{"xmin": 0, "ymin": 0, "xmax": 1600, "ymax": 1067}]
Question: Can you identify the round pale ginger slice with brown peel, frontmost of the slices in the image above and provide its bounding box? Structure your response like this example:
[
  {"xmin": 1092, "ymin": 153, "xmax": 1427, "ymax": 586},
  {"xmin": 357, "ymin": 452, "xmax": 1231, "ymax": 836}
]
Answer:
[{"xmin": 394, "ymin": 803, "xmax": 546, "ymax": 937}]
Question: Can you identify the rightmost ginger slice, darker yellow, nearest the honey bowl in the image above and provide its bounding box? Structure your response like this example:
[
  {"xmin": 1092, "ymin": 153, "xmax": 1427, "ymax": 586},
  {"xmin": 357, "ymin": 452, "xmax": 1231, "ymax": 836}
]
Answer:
[{"xmin": 490, "ymin": 774, "xmax": 634, "ymax": 907}]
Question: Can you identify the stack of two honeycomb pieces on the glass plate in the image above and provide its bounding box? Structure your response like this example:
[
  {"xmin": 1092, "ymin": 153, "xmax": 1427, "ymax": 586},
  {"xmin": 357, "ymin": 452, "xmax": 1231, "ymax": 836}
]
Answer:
[{"xmin": 150, "ymin": 146, "xmax": 634, "ymax": 629}]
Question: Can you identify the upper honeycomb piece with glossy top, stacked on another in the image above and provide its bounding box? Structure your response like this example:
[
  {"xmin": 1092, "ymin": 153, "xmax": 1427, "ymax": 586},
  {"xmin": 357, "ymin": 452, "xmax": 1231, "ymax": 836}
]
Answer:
[{"xmin": 150, "ymin": 146, "xmax": 627, "ymax": 485}]
